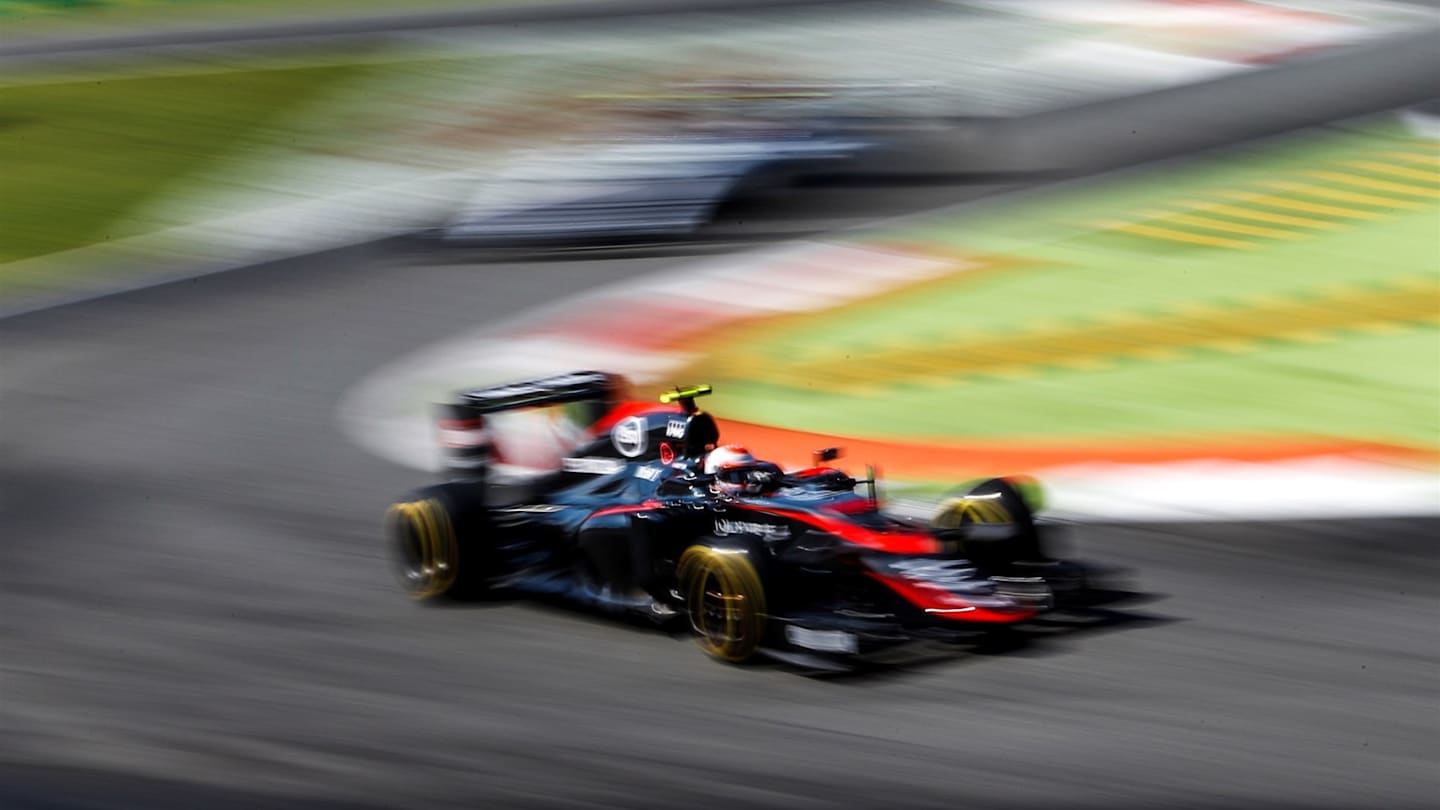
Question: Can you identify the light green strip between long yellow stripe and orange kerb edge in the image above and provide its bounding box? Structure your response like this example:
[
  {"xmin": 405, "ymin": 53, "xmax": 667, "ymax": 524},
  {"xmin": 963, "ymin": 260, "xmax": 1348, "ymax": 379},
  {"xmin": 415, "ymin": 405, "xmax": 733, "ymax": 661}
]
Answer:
[{"xmin": 716, "ymin": 327, "xmax": 1440, "ymax": 448}]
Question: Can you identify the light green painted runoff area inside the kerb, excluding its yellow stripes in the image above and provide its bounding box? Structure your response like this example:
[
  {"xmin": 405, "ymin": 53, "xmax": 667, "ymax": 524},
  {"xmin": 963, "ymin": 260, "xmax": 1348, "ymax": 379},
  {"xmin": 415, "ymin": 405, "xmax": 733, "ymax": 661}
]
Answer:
[{"xmin": 693, "ymin": 120, "xmax": 1440, "ymax": 448}]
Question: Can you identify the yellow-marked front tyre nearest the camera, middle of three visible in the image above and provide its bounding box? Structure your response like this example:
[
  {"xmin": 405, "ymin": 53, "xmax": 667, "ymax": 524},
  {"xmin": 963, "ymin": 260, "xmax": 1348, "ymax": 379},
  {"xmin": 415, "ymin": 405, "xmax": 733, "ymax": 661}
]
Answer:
[{"xmin": 675, "ymin": 545, "xmax": 769, "ymax": 663}]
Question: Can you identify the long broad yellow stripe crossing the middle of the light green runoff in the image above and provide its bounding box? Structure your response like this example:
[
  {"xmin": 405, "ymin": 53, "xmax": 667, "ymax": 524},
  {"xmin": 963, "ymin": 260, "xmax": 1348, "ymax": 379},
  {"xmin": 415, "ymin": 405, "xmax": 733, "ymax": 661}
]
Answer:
[{"xmin": 711, "ymin": 274, "xmax": 1440, "ymax": 392}]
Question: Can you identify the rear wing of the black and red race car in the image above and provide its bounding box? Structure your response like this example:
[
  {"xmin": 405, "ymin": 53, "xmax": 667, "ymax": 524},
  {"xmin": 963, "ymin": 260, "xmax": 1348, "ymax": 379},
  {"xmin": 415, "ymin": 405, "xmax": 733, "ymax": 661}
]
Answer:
[{"xmin": 436, "ymin": 370, "xmax": 628, "ymax": 477}]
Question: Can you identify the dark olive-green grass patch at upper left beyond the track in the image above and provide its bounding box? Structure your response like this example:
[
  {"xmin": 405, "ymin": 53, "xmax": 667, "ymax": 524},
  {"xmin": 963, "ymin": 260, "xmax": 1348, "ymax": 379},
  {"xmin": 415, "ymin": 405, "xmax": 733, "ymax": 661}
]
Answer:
[{"xmin": 0, "ymin": 65, "xmax": 366, "ymax": 262}]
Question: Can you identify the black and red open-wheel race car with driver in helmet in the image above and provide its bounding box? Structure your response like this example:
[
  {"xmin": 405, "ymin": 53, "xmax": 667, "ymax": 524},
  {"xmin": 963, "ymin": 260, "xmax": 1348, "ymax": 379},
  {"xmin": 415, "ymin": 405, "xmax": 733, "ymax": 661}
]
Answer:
[{"xmin": 386, "ymin": 372, "xmax": 1084, "ymax": 666}]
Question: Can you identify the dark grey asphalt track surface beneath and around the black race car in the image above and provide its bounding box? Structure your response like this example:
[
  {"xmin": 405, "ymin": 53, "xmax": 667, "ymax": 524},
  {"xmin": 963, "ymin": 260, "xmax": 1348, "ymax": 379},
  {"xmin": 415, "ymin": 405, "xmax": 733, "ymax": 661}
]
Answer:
[{"xmin": 0, "ymin": 230, "xmax": 1440, "ymax": 809}]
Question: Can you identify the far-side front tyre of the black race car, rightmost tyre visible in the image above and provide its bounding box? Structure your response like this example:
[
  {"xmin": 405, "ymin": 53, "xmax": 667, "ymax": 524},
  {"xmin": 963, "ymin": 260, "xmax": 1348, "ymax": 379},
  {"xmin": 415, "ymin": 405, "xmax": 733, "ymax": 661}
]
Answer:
[{"xmin": 930, "ymin": 479, "xmax": 1044, "ymax": 569}]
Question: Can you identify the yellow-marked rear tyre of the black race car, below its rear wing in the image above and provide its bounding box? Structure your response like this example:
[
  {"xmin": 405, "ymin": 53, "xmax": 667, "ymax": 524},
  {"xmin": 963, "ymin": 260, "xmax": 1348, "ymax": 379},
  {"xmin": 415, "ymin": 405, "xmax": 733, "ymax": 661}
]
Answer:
[{"xmin": 384, "ymin": 484, "xmax": 491, "ymax": 600}]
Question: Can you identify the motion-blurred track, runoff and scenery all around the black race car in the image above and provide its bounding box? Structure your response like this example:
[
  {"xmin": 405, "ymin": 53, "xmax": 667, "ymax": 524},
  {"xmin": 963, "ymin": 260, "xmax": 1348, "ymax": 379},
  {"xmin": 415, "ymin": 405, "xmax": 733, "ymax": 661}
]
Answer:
[{"xmin": 0, "ymin": 0, "xmax": 1440, "ymax": 807}]
